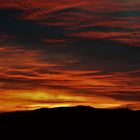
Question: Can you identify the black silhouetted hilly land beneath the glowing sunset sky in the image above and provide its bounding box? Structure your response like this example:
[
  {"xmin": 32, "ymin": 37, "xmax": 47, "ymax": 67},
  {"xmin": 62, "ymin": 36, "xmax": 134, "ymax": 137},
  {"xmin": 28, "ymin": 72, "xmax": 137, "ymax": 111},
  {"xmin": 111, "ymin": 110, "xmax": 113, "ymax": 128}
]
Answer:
[{"xmin": 0, "ymin": 106, "xmax": 140, "ymax": 140}]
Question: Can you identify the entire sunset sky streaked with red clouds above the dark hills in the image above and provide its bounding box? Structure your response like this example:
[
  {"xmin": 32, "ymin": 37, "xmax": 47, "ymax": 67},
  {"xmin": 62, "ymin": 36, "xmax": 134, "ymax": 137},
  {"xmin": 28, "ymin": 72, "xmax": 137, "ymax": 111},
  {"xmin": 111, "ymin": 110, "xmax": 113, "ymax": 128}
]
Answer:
[{"xmin": 0, "ymin": 0, "xmax": 140, "ymax": 111}]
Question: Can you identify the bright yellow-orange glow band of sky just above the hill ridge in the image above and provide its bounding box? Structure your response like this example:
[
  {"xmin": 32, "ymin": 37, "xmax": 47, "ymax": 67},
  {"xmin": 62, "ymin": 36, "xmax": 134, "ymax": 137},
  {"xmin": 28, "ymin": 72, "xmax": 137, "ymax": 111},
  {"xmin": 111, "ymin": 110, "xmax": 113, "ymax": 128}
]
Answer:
[{"xmin": 0, "ymin": 90, "xmax": 138, "ymax": 111}]
